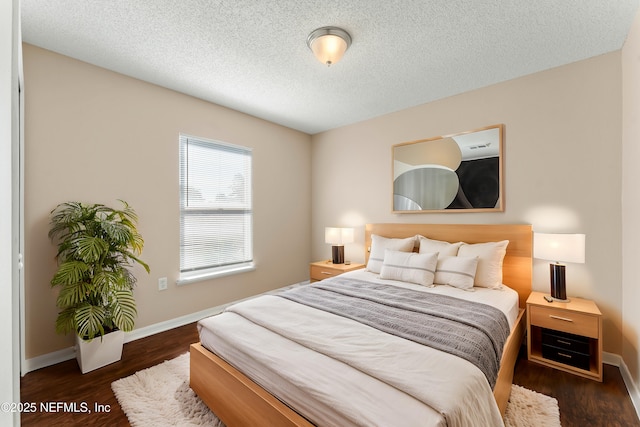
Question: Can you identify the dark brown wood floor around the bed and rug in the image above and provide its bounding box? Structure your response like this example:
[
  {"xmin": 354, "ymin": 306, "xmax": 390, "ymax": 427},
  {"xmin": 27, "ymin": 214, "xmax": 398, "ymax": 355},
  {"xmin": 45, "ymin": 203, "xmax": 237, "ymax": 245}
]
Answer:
[{"xmin": 21, "ymin": 324, "xmax": 640, "ymax": 427}]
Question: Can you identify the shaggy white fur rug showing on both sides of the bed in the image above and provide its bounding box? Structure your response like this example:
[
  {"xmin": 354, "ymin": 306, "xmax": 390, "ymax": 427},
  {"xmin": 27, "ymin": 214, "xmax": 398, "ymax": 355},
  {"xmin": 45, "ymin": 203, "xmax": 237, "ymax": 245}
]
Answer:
[{"xmin": 111, "ymin": 353, "xmax": 560, "ymax": 427}]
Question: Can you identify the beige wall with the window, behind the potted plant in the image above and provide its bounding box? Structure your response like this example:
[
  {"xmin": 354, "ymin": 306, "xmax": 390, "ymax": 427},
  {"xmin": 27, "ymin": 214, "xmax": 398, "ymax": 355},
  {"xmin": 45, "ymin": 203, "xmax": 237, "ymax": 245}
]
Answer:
[{"xmin": 24, "ymin": 45, "xmax": 311, "ymax": 359}]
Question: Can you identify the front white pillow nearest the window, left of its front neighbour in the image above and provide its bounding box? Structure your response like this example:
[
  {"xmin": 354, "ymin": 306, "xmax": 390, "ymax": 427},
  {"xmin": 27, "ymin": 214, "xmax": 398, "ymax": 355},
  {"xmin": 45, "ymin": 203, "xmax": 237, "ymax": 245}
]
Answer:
[{"xmin": 380, "ymin": 249, "xmax": 438, "ymax": 286}]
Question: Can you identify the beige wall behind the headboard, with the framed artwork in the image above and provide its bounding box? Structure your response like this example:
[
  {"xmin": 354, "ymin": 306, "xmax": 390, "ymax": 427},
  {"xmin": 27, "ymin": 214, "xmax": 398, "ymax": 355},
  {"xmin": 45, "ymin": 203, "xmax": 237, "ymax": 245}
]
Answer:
[{"xmin": 311, "ymin": 52, "xmax": 622, "ymax": 354}]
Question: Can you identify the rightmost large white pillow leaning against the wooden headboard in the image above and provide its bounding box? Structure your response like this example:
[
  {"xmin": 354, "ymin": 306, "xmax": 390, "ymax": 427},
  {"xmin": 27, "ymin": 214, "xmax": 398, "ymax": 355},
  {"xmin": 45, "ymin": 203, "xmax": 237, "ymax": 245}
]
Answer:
[{"xmin": 458, "ymin": 240, "xmax": 509, "ymax": 288}]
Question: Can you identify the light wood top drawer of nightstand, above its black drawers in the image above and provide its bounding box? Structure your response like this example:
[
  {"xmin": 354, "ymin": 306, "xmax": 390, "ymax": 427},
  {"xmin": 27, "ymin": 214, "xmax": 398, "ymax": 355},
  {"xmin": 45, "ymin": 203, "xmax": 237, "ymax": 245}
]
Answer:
[{"xmin": 529, "ymin": 306, "xmax": 600, "ymax": 338}]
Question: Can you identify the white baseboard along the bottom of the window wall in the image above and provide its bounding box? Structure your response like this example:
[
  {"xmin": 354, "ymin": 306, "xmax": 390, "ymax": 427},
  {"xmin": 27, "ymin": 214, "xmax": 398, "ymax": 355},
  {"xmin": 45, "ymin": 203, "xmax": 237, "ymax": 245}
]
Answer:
[{"xmin": 21, "ymin": 280, "xmax": 309, "ymax": 376}]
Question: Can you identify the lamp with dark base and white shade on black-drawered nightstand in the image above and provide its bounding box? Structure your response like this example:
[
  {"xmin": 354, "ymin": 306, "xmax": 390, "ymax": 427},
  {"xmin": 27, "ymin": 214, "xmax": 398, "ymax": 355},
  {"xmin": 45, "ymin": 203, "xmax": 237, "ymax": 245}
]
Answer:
[{"xmin": 533, "ymin": 233, "xmax": 585, "ymax": 302}]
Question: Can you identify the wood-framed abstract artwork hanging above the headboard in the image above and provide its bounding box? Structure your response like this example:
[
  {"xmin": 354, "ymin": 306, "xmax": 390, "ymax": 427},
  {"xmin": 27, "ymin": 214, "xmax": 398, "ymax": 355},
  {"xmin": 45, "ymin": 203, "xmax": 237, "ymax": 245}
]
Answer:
[{"xmin": 392, "ymin": 124, "xmax": 504, "ymax": 213}]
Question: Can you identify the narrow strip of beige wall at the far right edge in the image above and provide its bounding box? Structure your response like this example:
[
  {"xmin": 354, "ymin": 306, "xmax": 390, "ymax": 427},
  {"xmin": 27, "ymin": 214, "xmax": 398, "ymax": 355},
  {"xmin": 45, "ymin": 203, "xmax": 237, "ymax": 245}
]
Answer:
[{"xmin": 622, "ymin": 13, "xmax": 640, "ymax": 390}]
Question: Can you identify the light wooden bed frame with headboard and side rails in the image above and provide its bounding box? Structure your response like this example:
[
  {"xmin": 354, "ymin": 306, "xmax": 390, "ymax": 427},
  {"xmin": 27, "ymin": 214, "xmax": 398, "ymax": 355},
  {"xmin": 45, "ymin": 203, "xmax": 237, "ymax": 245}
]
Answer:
[{"xmin": 190, "ymin": 224, "xmax": 532, "ymax": 427}]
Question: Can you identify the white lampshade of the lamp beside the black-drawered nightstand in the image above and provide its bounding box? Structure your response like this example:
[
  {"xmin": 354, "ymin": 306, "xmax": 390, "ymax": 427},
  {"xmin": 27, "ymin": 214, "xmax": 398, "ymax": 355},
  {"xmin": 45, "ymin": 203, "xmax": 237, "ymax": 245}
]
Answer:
[{"xmin": 533, "ymin": 233, "xmax": 585, "ymax": 264}]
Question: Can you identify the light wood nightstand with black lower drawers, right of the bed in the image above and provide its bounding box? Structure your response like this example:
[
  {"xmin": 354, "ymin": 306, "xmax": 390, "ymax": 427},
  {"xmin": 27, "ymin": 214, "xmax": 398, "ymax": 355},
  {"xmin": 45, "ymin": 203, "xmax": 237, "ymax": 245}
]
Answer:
[{"xmin": 527, "ymin": 292, "xmax": 602, "ymax": 382}]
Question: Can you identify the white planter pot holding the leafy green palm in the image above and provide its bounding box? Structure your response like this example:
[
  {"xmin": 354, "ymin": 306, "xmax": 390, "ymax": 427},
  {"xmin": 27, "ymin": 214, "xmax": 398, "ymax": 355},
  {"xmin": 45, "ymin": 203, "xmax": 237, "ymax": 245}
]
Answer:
[{"xmin": 76, "ymin": 331, "xmax": 124, "ymax": 374}]
